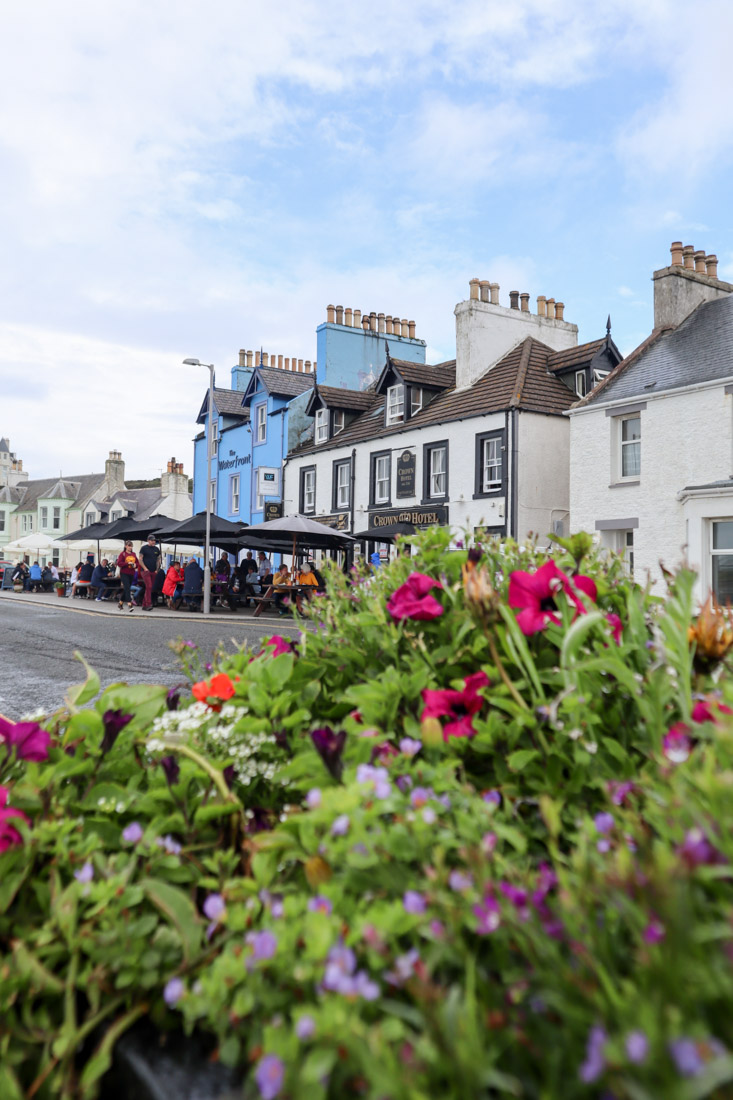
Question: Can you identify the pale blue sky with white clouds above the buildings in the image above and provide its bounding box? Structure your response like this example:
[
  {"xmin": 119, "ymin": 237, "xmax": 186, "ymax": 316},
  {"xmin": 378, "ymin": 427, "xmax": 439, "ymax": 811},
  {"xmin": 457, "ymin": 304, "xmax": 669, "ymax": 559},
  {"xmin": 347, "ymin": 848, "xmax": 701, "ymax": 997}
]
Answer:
[{"xmin": 0, "ymin": 0, "xmax": 733, "ymax": 479}]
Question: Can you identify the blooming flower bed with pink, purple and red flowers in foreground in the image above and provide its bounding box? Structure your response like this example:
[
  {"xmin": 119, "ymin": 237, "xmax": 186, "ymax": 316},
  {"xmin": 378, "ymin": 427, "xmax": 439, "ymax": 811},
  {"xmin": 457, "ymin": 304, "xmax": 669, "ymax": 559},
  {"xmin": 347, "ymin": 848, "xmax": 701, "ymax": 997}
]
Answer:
[{"xmin": 0, "ymin": 530, "xmax": 733, "ymax": 1100}]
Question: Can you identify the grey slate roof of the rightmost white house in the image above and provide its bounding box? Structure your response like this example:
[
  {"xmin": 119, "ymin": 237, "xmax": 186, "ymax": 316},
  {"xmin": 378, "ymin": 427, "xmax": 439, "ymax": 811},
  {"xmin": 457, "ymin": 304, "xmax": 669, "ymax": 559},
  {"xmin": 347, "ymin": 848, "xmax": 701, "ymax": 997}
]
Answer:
[{"xmin": 573, "ymin": 295, "xmax": 733, "ymax": 408}]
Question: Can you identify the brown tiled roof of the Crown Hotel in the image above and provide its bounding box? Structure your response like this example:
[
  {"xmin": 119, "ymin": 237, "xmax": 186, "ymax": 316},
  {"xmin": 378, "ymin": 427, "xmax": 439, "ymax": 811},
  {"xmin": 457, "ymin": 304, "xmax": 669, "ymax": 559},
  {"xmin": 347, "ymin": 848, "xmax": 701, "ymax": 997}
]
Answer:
[{"xmin": 291, "ymin": 337, "xmax": 575, "ymax": 457}]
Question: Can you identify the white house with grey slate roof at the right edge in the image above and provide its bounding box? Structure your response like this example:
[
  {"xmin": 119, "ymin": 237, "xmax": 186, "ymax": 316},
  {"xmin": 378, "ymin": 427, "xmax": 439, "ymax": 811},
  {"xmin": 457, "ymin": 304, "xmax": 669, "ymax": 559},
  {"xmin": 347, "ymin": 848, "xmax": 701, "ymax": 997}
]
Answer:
[{"xmin": 569, "ymin": 242, "xmax": 733, "ymax": 602}]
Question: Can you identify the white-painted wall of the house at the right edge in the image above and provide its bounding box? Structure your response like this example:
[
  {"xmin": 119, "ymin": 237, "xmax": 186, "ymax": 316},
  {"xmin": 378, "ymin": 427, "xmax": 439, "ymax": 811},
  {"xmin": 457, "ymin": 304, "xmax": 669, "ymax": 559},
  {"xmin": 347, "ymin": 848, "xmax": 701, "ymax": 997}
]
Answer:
[{"xmin": 570, "ymin": 382, "xmax": 733, "ymax": 582}]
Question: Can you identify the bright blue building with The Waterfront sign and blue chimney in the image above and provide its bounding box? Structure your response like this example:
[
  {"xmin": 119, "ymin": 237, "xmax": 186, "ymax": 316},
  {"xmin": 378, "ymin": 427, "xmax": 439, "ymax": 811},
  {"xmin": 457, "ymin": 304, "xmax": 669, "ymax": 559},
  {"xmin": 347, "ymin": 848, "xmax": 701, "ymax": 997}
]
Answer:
[{"xmin": 194, "ymin": 306, "xmax": 426, "ymax": 524}]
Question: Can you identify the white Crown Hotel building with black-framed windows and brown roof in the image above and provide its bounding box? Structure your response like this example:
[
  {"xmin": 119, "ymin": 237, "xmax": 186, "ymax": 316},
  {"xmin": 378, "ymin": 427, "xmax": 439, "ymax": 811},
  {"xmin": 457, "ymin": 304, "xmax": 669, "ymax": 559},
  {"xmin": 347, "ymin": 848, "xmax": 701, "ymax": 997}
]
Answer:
[{"xmin": 284, "ymin": 279, "xmax": 621, "ymax": 539}]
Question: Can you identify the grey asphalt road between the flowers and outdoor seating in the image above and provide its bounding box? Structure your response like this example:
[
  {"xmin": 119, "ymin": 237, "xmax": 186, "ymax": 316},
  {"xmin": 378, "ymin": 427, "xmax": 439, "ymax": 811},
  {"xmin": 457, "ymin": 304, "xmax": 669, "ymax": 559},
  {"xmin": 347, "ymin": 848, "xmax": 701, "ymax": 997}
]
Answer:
[{"xmin": 0, "ymin": 600, "xmax": 298, "ymax": 721}]
